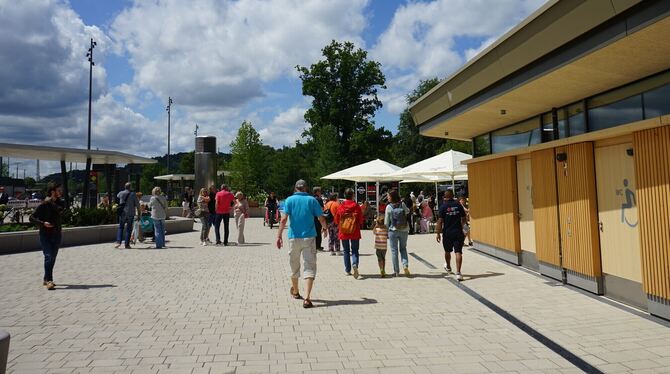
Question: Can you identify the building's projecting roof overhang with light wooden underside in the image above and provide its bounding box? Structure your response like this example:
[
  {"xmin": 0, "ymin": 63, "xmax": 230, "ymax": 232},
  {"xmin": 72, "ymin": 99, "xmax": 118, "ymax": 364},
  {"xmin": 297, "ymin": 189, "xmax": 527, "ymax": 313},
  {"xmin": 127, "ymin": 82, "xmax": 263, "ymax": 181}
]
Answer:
[{"xmin": 410, "ymin": 1, "xmax": 670, "ymax": 140}]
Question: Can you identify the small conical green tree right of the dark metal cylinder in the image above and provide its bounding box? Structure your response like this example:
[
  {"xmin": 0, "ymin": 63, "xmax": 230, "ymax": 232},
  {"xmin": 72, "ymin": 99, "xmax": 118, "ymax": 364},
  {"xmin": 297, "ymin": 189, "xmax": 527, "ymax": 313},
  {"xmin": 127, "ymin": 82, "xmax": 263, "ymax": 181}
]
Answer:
[{"xmin": 226, "ymin": 121, "xmax": 268, "ymax": 195}]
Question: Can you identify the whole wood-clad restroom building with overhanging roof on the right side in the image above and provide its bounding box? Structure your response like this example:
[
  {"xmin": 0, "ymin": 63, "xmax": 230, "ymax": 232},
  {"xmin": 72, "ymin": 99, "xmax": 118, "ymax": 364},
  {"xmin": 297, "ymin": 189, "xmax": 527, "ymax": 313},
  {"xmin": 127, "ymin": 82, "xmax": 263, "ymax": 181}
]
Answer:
[{"xmin": 410, "ymin": 0, "xmax": 670, "ymax": 319}]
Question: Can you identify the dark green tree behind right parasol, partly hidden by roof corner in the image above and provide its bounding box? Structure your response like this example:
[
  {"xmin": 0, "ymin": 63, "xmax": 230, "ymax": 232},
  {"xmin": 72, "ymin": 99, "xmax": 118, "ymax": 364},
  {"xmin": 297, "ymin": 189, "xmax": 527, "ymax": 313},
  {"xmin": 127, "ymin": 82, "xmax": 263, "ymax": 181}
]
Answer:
[{"xmin": 393, "ymin": 78, "xmax": 472, "ymax": 166}]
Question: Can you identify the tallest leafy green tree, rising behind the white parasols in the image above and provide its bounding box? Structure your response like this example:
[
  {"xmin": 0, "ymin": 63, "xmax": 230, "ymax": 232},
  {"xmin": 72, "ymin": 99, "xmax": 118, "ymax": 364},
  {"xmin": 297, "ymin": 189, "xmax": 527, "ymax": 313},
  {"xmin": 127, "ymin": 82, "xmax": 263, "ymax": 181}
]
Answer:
[{"xmin": 296, "ymin": 40, "xmax": 386, "ymax": 167}]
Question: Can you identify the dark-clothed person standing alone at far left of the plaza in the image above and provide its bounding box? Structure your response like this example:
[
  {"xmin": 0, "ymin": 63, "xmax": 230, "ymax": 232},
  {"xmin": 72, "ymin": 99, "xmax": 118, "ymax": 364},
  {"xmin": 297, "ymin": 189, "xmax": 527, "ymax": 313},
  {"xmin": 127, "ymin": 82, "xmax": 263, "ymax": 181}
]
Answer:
[{"xmin": 30, "ymin": 184, "xmax": 63, "ymax": 290}]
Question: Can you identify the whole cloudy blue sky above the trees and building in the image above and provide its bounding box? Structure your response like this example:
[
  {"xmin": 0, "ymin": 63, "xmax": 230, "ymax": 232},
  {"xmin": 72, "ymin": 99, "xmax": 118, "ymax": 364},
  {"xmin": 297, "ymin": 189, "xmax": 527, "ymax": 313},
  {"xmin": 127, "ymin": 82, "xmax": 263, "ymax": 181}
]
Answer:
[{"xmin": 0, "ymin": 0, "xmax": 544, "ymax": 178}]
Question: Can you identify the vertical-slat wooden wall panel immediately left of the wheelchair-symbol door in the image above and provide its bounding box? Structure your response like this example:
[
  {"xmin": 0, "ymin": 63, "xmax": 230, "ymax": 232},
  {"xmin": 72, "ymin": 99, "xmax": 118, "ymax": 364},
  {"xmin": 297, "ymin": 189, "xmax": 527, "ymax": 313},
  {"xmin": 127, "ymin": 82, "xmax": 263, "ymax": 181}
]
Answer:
[{"xmin": 556, "ymin": 142, "xmax": 602, "ymax": 277}]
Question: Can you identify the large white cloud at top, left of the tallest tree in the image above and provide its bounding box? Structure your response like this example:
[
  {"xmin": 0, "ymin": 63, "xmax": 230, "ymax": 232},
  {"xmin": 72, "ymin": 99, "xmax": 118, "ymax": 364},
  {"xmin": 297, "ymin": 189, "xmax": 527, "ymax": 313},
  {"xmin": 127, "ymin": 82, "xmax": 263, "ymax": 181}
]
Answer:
[{"xmin": 112, "ymin": 0, "xmax": 367, "ymax": 108}]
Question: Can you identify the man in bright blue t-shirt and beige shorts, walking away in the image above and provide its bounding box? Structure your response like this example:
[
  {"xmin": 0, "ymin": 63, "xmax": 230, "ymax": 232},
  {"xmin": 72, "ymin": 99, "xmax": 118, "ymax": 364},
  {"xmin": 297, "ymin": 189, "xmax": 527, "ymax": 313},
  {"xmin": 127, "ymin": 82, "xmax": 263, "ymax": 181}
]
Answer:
[{"xmin": 277, "ymin": 179, "xmax": 328, "ymax": 308}]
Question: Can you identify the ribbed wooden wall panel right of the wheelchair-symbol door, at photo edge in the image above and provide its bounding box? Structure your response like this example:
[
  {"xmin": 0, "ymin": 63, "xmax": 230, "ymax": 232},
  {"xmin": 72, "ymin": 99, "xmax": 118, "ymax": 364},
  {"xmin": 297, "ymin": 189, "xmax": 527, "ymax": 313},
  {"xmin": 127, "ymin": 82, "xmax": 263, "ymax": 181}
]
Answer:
[{"xmin": 633, "ymin": 126, "xmax": 670, "ymax": 300}]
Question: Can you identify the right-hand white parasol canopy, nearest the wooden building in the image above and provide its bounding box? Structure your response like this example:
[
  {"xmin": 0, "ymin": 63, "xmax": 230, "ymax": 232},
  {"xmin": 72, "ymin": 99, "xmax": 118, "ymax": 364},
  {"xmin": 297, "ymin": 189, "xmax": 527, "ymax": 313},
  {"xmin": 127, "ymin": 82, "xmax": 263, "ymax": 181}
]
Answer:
[{"xmin": 389, "ymin": 150, "xmax": 472, "ymax": 180}]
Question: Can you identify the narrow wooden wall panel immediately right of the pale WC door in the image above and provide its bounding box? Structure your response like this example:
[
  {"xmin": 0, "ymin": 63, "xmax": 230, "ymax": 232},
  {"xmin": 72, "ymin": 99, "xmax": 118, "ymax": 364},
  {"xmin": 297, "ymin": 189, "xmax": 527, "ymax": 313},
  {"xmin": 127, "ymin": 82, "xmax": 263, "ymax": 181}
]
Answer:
[{"xmin": 530, "ymin": 149, "xmax": 561, "ymax": 266}]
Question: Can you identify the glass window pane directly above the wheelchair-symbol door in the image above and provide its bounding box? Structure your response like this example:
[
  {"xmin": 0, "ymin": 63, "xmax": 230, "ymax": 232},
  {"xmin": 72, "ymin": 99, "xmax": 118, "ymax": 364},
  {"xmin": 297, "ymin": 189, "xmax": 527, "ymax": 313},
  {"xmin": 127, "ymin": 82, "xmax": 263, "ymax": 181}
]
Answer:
[{"xmin": 588, "ymin": 94, "xmax": 643, "ymax": 131}]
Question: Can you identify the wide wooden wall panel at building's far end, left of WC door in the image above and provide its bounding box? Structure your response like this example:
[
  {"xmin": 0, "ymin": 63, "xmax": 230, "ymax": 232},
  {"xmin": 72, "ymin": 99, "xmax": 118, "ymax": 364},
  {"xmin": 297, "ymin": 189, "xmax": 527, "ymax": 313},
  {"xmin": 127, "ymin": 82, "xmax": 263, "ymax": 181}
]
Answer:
[{"xmin": 468, "ymin": 157, "xmax": 521, "ymax": 253}]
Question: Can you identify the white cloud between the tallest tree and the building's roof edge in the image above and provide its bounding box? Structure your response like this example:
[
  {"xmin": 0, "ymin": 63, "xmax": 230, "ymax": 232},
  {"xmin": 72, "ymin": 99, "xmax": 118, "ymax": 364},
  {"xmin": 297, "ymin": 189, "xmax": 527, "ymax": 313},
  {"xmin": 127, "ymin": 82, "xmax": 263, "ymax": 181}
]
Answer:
[{"xmin": 371, "ymin": 0, "xmax": 545, "ymax": 113}]
